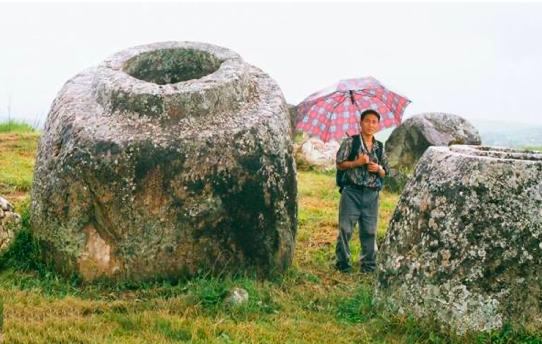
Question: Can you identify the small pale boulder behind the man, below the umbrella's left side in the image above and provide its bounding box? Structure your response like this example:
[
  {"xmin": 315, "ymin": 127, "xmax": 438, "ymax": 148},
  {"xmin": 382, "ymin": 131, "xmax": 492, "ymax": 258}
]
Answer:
[{"xmin": 294, "ymin": 134, "xmax": 340, "ymax": 171}]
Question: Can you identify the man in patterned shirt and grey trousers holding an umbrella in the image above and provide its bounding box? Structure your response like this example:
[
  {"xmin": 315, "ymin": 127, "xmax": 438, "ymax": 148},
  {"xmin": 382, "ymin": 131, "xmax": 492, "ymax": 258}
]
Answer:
[{"xmin": 335, "ymin": 110, "xmax": 389, "ymax": 273}]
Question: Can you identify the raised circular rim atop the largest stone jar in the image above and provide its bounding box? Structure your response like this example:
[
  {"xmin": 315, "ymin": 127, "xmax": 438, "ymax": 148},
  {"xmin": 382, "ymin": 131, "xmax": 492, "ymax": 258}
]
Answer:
[{"xmin": 91, "ymin": 42, "xmax": 250, "ymax": 120}]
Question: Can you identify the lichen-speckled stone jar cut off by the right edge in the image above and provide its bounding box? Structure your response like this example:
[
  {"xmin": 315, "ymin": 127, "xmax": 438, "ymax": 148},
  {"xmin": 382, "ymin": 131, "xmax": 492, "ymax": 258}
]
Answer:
[{"xmin": 377, "ymin": 145, "xmax": 542, "ymax": 333}]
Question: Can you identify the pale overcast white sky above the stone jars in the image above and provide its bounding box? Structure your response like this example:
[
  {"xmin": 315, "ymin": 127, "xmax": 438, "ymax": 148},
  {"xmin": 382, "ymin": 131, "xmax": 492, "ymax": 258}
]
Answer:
[{"xmin": 0, "ymin": 3, "xmax": 542, "ymax": 125}]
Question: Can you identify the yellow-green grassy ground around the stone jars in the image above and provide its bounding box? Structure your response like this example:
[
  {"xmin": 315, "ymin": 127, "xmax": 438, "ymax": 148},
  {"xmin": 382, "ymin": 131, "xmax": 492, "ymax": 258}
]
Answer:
[{"xmin": 0, "ymin": 127, "xmax": 540, "ymax": 344}]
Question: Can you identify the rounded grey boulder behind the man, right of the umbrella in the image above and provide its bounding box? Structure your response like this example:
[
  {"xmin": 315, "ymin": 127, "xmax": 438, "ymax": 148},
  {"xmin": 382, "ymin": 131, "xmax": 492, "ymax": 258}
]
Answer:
[{"xmin": 386, "ymin": 113, "xmax": 482, "ymax": 192}]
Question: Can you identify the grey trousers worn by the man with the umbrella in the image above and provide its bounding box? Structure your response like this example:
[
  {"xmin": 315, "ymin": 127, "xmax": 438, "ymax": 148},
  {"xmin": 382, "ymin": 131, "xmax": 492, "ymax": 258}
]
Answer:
[{"xmin": 335, "ymin": 186, "xmax": 379, "ymax": 272}]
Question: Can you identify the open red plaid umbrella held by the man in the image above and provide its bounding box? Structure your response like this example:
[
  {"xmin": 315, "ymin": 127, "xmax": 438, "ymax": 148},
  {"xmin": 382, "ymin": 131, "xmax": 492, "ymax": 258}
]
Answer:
[{"xmin": 296, "ymin": 76, "xmax": 411, "ymax": 142}]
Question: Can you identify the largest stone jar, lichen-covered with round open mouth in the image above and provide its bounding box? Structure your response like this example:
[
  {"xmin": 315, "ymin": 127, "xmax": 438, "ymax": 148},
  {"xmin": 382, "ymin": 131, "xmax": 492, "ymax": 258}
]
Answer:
[{"xmin": 31, "ymin": 42, "xmax": 297, "ymax": 281}]
